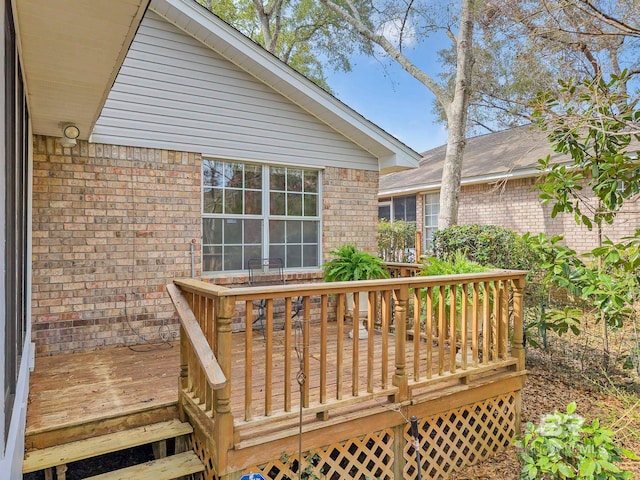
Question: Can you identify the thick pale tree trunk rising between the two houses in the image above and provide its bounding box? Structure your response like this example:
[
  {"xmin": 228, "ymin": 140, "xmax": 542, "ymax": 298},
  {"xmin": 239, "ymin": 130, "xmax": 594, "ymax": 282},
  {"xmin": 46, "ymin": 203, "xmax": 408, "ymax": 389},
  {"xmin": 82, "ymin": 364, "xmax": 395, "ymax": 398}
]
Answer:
[{"xmin": 438, "ymin": 0, "xmax": 473, "ymax": 229}]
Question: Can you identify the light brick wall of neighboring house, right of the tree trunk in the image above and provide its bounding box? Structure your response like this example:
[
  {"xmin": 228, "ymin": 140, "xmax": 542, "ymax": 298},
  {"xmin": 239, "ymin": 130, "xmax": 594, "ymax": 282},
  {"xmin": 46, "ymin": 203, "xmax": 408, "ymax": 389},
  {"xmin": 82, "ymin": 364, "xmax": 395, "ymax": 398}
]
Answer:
[{"xmin": 458, "ymin": 178, "xmax": 640, "ymax": 252}]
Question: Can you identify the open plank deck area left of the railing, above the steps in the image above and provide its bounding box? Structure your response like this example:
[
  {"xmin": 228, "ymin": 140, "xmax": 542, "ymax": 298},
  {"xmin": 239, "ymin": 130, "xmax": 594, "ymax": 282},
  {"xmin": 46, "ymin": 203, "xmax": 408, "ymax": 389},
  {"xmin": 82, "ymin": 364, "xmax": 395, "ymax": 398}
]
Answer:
[{"xmin": 26, "ymin": 343, "xmax": 180, "ymax": 450}]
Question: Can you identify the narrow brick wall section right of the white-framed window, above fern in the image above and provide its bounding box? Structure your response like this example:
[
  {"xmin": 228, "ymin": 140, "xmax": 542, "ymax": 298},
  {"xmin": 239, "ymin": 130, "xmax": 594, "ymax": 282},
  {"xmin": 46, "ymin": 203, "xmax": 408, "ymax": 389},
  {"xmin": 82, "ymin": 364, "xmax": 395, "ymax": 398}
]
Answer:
[{"xmin": 322, "ymin": 167, "xmax": 378, "ymax": 260}]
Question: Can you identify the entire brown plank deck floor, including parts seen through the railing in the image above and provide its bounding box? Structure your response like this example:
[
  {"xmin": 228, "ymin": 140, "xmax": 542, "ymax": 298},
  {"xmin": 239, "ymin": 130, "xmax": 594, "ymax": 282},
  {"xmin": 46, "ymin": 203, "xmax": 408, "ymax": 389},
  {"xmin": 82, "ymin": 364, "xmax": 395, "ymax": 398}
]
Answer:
[{"xmin": 26, "ymin": 324, "xmax": 436, "ymax": 450}]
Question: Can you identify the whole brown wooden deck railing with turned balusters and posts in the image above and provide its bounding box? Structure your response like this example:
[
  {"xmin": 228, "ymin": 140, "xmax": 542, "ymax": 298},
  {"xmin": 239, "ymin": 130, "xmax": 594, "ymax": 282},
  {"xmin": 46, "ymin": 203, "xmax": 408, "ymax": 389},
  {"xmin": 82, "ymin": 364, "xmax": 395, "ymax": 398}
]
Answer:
[{"xmin": 169, "ymin": 266, "xmax": 525, "ymax": 467}]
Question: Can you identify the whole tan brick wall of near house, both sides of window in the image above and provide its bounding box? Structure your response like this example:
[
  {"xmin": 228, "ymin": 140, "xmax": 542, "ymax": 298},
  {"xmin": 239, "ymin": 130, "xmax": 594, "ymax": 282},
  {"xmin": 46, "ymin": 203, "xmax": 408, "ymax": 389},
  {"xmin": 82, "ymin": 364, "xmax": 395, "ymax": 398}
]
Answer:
[{"xmin": 32, "ymin": 136, "xmax": 378, "ymax": 355}]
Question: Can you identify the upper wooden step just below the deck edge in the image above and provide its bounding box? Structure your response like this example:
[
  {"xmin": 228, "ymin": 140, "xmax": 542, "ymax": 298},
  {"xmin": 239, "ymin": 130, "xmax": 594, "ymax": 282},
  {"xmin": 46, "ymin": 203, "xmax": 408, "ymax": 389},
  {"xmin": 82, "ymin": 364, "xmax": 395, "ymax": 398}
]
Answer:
[{"xmin": 22, "ymin": 420, "xmax": 193, "ymax": 473}]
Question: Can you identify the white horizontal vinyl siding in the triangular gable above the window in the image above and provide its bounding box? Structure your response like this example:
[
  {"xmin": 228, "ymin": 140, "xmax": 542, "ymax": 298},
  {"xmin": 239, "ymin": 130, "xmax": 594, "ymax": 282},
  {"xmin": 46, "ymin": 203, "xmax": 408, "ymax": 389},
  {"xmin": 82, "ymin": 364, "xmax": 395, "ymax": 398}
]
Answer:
[{"xmin": 92, "ymin": 11, "xmax": 378, "ymax": 170}]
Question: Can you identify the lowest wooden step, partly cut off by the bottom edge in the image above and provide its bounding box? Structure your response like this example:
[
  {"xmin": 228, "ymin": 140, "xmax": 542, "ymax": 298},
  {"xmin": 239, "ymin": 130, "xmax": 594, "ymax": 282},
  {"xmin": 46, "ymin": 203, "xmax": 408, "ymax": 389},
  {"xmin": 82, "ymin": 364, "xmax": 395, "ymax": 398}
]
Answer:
[{"xmin": 85, "ymin": 451, "xmax": 204, "ymax": 480}]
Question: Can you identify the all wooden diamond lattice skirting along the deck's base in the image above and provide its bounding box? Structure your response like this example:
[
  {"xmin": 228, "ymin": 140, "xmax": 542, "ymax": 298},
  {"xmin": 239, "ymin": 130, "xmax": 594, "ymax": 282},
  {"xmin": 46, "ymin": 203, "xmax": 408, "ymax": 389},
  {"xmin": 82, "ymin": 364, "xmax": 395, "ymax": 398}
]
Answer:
[{"xmin": 238, "ymin": 392, "xmax": 518, "ymax": 480}]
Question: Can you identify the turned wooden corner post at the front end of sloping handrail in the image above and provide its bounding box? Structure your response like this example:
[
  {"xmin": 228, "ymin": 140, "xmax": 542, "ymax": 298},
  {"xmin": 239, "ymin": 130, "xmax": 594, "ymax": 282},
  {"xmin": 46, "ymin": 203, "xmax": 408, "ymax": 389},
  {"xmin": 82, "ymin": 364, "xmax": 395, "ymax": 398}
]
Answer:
[{"xmin": 212, "ymin": 297, "xmax": 236, "ymax": 478}]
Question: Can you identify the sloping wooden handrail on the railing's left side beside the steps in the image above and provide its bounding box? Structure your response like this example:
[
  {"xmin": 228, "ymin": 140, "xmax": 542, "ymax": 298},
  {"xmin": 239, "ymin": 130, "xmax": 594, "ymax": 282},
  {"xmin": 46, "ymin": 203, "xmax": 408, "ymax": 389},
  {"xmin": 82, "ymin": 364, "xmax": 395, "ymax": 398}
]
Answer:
[{"xmin": 167, "ymin": 283, "xmax": 227, "ymax": 390}]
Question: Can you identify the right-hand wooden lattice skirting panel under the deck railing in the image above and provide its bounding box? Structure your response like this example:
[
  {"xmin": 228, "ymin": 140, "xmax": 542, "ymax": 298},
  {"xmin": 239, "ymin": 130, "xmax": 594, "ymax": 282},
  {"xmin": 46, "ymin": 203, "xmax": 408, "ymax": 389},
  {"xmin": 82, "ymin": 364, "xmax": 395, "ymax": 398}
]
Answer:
[{"xmin": 403, "ymin": 393, "xmax": 517, "ymax": 480}]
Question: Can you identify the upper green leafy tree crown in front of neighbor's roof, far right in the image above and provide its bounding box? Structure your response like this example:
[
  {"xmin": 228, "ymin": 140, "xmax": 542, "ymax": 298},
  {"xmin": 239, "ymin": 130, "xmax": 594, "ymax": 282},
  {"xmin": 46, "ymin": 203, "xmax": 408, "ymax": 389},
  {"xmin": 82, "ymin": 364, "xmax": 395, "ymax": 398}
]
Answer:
[{"xmin": 534, "ymin": 72, "xmax": 640, "ymax": 229}]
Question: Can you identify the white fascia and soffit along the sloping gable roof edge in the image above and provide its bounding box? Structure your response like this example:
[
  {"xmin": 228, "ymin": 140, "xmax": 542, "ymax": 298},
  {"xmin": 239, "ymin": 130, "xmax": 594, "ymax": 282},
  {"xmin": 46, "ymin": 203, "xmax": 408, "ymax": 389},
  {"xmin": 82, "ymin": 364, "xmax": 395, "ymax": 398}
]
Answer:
[{"xmin": 149, "ymin": 0, "xmax": 421, "ymax": 173}]
